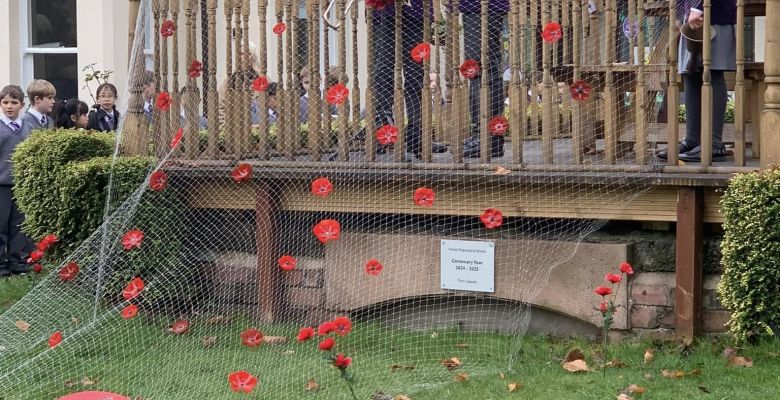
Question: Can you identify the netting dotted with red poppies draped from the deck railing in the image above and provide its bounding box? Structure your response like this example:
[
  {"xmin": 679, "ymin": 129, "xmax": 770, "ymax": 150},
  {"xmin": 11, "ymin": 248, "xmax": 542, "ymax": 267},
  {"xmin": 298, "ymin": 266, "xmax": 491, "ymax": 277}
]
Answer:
[{"xmin": 0, "ymin": 0, "xmax": 676, "ymax": 399}]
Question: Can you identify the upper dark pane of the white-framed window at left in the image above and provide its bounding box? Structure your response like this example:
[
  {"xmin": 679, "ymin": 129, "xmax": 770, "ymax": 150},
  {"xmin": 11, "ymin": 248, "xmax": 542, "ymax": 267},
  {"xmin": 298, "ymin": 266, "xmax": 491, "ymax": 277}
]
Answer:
[{"xmin": 30, "ymin": 0, "xmax": 76, "ymax": 47}]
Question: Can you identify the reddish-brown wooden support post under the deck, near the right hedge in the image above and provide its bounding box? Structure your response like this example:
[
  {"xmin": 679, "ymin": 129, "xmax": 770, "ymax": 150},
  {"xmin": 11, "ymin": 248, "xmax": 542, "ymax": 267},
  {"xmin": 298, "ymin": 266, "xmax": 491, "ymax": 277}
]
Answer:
[{"xmin": 674, "ymin": 187, "xmax": 704, "ymax": 343}]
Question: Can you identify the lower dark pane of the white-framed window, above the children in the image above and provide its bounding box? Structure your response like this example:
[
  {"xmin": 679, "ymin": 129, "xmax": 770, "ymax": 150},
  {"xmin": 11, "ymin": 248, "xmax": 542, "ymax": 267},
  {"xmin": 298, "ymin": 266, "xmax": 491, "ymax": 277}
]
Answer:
[{"xmin": 33, "ymin": 54, "xmax": 78, "ymax": 103}]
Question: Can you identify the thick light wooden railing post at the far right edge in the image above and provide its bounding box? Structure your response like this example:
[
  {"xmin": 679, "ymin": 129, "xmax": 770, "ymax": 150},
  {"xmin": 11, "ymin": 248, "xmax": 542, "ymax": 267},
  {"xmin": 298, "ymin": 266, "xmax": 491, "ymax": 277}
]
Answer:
[{"xmin": 761, "ymin": 0, "xmax": 780, "ymax": 168}]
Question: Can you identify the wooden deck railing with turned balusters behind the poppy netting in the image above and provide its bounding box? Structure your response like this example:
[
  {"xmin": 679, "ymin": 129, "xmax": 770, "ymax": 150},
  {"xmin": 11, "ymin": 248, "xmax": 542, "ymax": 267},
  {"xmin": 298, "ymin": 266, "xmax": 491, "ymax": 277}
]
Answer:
[{"xmin": 123, "ymin": 0, "xmax": 780, "ymax": 171}]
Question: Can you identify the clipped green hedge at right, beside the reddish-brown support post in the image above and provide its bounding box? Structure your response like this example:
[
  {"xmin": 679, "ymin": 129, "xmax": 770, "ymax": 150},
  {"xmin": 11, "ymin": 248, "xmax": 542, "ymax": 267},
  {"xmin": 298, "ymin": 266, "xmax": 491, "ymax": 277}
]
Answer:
[{"xmin": 718, "ymin": 169, "xmax": 780, "ymax": 341}]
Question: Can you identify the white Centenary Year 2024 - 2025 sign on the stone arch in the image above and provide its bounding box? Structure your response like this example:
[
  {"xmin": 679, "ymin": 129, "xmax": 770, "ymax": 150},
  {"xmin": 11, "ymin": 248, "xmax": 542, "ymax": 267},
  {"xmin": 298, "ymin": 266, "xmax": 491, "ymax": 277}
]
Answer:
[{"xmin": 441, "ymin": 239, "xmax": 496, "ymax": 293}]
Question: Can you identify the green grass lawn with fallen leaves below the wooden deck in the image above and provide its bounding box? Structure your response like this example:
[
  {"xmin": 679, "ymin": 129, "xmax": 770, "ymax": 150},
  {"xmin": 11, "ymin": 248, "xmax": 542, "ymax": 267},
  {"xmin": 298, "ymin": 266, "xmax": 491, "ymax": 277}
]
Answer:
[{"xmin": 0, "ymin": 277, "xmax": 780, "ymax": 400}]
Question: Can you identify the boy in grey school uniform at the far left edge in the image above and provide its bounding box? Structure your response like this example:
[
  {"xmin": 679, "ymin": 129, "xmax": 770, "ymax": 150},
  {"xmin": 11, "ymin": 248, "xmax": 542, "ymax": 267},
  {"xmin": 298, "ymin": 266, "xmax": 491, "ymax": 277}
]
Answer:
[{"xmin": 0, "ymin": 85, "xmax": 32, "ymax": 277}]
